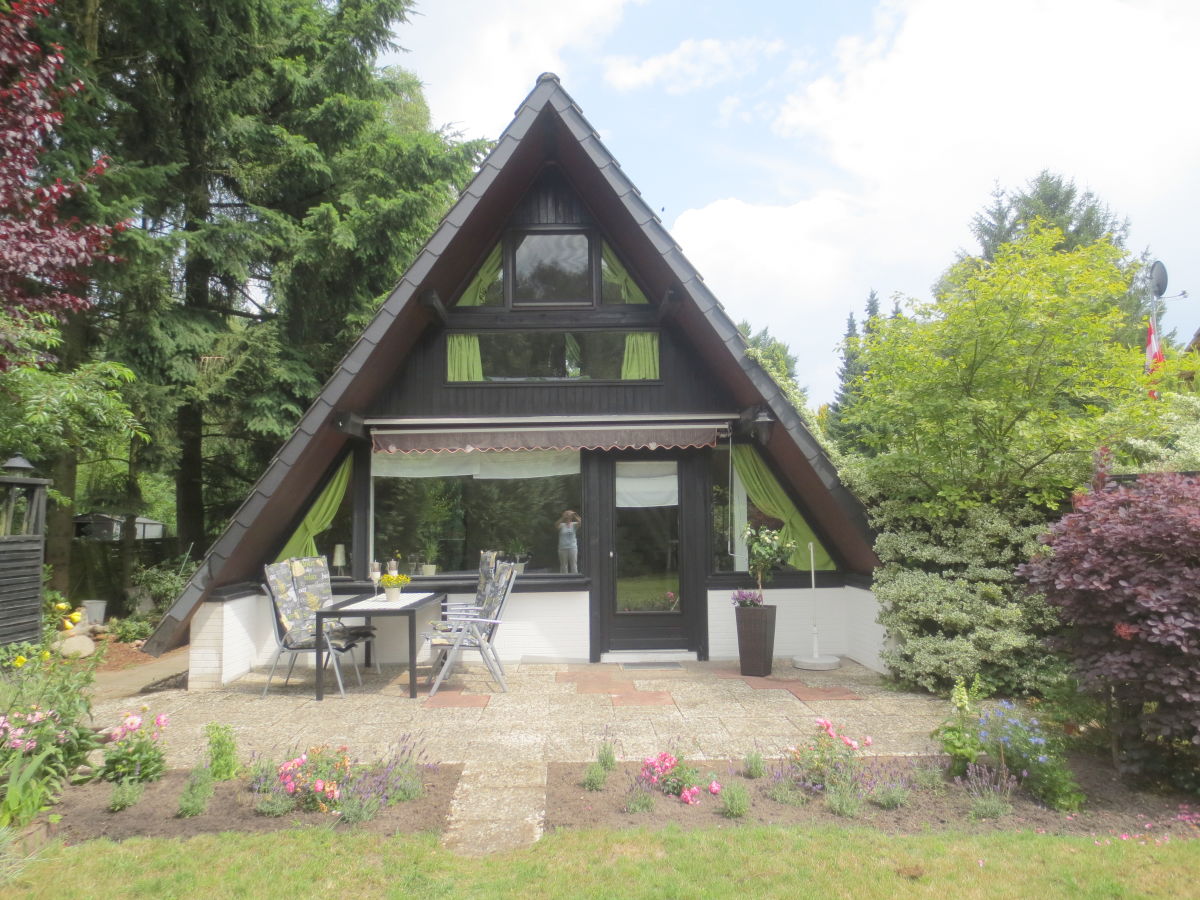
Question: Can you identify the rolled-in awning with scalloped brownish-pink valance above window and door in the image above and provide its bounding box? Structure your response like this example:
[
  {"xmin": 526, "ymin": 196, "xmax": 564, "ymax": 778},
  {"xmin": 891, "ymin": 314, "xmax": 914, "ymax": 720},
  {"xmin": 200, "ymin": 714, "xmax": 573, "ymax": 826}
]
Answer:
[{"xmin": 371, "ymin": 422, "xmax": 728, "ymax": 454}]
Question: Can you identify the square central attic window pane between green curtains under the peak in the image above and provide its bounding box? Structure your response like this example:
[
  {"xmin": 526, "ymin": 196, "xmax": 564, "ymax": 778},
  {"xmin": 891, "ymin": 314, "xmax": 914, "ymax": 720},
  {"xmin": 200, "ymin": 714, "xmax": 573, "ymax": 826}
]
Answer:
[{"xmin": 512, "ymin": 233, "xmax": 593, "ymax": 306}]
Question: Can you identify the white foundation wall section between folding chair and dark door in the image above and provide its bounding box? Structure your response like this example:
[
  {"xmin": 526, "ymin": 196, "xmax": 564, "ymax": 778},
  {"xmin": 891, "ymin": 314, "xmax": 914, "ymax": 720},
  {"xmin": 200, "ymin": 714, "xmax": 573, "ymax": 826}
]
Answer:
[{"xmin": 496, "ymin": 592, "xmax": 592, "ymax": 662}]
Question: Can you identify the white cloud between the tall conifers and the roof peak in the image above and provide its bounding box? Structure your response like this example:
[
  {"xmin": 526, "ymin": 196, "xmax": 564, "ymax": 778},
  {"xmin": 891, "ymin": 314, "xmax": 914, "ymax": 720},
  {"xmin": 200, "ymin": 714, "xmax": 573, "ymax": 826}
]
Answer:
[{"xmin": 386, "ymin": 0, "xmax": 640, "ymax": 138}]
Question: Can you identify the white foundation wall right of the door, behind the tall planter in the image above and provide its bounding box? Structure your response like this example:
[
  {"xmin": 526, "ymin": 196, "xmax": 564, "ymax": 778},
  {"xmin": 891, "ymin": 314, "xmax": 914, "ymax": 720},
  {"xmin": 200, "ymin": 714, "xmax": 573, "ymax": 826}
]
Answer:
[{"xmin": 708, "ymin": 588, "xmax": 883, "ymax": 672}]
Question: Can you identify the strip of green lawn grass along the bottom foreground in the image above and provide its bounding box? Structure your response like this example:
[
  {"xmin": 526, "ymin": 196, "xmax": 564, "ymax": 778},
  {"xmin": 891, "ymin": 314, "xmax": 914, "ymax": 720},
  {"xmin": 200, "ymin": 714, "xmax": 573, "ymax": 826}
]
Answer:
[{"xmin": 6, "ymin": 826, "xmax": 1200, "ymax": 900}]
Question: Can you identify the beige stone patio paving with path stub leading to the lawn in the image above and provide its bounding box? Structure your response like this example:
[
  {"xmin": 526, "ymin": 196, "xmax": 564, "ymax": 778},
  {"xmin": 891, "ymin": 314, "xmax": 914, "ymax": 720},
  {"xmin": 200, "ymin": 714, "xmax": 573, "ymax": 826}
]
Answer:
[{"xmin": 94, "ymin": 660, "xmax": 948, "ymax": 852}]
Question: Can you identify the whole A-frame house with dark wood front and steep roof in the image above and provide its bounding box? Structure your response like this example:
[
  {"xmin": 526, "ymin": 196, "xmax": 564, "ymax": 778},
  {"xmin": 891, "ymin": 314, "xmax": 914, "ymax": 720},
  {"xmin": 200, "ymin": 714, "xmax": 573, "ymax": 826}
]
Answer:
[{"xmin": 148, "ymin": 74, "xmax": 883, "ymax": 689}]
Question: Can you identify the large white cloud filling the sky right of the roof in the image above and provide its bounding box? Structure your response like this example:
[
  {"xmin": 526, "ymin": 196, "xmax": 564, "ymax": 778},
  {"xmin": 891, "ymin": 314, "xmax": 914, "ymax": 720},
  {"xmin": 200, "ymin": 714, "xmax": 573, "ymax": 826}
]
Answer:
[{"xmin": 674, "ymin": 0, "xmax": 1200, "ymax": 401}]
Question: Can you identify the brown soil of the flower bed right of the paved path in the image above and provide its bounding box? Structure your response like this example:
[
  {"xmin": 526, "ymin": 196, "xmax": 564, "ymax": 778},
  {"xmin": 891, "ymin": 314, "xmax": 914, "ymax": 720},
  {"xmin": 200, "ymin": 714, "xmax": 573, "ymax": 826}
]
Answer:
[{"xmin": 546, "ymin": 757, "xmax": 1200, "ymax": 842}]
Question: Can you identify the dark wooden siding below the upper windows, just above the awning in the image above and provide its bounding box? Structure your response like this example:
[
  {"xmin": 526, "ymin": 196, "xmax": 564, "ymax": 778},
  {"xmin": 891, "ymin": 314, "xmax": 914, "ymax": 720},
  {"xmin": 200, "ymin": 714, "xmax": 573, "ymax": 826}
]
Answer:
[{"xmin": 367, "ymin": 329, "xmax": 737, "ymax": 418}]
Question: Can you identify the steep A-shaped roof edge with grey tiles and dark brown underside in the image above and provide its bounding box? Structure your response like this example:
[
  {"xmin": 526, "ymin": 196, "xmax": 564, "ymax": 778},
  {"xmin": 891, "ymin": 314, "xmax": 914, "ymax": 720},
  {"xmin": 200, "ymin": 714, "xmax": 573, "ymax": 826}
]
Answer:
[{"xmin": 145, "ymin": 73, "xmax": 877, "ymax": 654}]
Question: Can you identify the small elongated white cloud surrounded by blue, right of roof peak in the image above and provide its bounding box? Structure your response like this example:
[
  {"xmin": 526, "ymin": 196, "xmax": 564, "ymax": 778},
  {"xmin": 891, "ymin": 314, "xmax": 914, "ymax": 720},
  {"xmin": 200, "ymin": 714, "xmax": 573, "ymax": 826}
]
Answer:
[{"xmin": 605, "ymin": 37, "xmax": 784, "ymax": 94}]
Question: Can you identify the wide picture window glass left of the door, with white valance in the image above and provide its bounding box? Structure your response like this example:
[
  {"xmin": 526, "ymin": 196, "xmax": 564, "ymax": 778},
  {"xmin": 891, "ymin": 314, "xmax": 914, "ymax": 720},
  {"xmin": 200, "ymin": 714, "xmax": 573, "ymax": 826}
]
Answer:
[{"xmin": 371, "ymin": 450, "xmax": 588, "ymax": 572}]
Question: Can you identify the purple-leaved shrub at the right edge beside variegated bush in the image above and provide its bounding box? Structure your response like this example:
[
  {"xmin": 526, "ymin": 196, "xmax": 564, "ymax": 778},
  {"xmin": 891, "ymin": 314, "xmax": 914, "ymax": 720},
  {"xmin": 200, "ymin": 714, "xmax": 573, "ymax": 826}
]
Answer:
[{"xmin": 1018, "ymin": 472, "xmax": 1200, "ymax": 786}]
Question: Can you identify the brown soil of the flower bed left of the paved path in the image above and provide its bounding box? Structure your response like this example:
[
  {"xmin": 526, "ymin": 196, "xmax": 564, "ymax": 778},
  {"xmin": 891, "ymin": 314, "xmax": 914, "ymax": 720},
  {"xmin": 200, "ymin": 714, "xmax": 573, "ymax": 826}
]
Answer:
[{"xmin": 49, "ymin": 766, "xmax": 462, "ymax": 844}]
